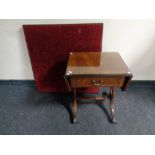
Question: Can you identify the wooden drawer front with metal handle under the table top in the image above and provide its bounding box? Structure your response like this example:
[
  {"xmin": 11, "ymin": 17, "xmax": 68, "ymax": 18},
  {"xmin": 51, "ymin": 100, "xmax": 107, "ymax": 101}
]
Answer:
[{"xmin": 71, "ymin": 77, "xmax": 124, "ymax": 88}]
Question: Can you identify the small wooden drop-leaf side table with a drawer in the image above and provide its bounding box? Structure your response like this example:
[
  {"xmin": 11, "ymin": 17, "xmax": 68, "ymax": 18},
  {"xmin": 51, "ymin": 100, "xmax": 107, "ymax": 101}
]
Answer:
[{"xmin": 64, "ymin": 52, "xmax": 133, "ymax": 123}]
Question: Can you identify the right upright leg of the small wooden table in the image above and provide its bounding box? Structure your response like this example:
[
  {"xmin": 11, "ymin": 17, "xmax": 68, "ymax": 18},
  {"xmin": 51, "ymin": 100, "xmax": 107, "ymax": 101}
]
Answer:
[{"xmin": 110, "ymin": 87, "xmax": 116, "ymax": 123}]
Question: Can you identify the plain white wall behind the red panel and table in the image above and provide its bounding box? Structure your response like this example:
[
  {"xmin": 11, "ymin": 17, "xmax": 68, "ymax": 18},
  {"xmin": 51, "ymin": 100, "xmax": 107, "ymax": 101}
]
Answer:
[{"xmin": 0, "ymin": 20, "xmax": 155, "ymax": 80}]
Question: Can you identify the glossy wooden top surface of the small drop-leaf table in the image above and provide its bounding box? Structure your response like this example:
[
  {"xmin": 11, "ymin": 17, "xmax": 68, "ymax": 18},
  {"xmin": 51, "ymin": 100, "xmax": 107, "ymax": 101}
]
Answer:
[{"xmin": 66, "ymin": 52, "xmax": 132, "ymax": 76}]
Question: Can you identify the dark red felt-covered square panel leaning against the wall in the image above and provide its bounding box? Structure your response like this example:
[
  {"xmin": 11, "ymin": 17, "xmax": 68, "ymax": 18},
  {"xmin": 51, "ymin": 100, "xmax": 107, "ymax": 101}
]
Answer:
[{"xmin": 23, "ymin": 23, "xmax": 103, "ymax": 93}]
